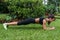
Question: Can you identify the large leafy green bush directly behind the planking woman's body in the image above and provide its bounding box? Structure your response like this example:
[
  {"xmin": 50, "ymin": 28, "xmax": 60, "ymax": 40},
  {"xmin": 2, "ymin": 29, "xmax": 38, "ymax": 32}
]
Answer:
[{"xmin": 8, "ymin": 0, "xmax": 45, "ymax": 19}]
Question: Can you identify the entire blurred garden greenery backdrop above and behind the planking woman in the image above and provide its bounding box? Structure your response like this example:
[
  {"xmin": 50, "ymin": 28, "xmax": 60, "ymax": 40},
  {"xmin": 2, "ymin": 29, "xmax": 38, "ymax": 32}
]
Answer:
[{"xmin": 0, "ymin": 0, "xmax": 60, "ymax": 23}]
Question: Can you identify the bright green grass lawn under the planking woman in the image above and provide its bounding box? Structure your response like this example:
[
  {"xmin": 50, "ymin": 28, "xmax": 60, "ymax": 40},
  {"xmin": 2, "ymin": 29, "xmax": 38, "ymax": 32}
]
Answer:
[{"xmin": 0, "ymin": 19, "xmax": 60, "ymax": 40}]
